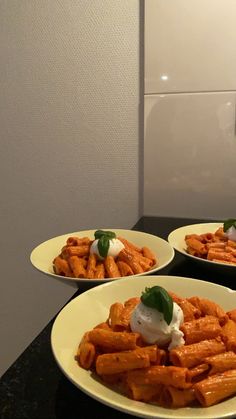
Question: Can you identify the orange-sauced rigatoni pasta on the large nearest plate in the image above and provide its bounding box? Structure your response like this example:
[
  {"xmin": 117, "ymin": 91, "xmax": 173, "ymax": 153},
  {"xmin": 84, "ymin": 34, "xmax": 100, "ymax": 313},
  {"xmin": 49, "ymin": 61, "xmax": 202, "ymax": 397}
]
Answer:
[{"xmin": 76, "ymin": 291, "xmax": 236, "ymax": 409}]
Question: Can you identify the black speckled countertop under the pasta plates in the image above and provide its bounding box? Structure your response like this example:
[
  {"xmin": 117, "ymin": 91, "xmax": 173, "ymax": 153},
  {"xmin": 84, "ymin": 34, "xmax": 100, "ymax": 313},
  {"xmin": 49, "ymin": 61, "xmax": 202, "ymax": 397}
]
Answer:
[{"xmin": 0, "ymin": 217, "xmax": 236, "ymax": 419}]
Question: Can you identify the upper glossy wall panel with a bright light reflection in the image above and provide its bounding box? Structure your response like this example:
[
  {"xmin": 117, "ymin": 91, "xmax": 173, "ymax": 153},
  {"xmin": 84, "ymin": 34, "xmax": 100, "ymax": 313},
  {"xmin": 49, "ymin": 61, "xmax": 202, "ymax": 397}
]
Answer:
[{"xmin": 145, "ymin": 0, "xmax": 236, "ymax": 93}]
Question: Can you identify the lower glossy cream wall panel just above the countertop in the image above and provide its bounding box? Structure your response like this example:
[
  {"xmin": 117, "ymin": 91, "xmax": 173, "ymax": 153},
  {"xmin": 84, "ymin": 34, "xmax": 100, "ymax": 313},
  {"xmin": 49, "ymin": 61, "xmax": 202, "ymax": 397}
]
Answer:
[{"xmin": 144, "ymin": 92, "xmax": 236, "ymax": 219}]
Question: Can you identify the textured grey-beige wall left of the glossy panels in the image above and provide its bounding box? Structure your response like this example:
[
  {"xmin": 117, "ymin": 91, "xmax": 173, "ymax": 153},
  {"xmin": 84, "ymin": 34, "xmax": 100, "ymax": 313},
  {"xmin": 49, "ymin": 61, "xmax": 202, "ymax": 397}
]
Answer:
[{"xmin": 0, "ymin": 0, "xmax": 141, "ymax": 374}]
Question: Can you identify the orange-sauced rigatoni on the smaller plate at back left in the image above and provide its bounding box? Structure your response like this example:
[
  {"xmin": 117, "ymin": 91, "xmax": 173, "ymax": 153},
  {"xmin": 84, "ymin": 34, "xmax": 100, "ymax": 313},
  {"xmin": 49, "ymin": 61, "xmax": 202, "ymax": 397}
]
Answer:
[{"xmin": 53, "ymin": 230, "xmax": 158, "ymax": 280}]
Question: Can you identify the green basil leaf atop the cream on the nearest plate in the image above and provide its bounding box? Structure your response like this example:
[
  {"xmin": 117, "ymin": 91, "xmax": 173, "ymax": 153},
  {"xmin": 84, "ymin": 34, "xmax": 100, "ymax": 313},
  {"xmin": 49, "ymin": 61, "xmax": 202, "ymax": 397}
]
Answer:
[{"xmin": 141, "ymin": 285, "xmax": 173, "ymax": 324}]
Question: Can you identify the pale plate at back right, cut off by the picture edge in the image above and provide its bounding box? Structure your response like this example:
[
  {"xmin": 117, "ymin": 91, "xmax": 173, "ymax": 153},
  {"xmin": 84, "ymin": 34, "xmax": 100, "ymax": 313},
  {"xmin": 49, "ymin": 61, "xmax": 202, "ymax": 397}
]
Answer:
[{"xmin": 168, "ymin": 223, "xmax": 236, "ymax": 271}]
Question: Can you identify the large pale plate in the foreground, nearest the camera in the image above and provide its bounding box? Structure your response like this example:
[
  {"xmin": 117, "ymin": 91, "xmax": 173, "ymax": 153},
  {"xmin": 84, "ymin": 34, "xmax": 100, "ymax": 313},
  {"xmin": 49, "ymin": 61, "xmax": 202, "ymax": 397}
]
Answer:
[{"xmin": 51, "ymin": 275, "xmax": 236, "ymax": 419}]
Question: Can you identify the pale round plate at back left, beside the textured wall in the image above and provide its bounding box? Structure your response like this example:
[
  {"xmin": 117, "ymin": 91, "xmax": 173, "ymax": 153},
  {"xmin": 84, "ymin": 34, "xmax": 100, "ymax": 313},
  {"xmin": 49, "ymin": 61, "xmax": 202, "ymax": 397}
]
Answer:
[{"xmin": 30, "ymin": 229, "xmax": 174, "ymax": 284}]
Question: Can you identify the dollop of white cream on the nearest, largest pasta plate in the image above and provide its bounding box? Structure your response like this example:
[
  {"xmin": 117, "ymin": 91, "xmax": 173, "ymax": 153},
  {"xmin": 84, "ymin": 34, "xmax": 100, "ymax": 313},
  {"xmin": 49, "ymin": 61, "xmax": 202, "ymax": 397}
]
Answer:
[{"xmin": 130, "ymin": 302, "xmax": 185, "ymax": 350}]
